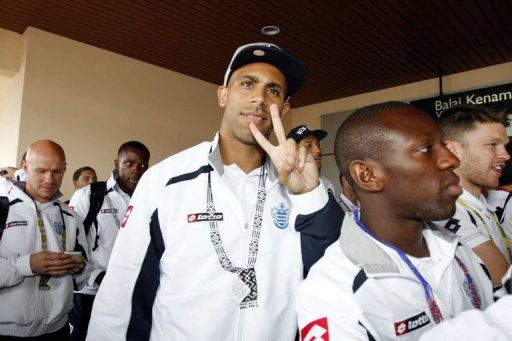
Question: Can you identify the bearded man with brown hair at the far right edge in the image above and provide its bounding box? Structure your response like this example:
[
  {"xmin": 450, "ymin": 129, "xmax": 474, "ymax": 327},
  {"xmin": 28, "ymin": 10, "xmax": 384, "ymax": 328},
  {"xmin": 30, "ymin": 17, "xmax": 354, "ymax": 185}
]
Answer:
[{"xmin": 436, "ymin": 105, "xmax": 512, "ymax": 286}]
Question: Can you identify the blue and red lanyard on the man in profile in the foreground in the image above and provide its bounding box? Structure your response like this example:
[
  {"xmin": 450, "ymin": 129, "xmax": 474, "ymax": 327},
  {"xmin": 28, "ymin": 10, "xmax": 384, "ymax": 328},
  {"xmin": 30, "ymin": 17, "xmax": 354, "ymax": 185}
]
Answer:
[{"xmin": 354, "ymin": 211, "xmax": 481, "ymax": 324}]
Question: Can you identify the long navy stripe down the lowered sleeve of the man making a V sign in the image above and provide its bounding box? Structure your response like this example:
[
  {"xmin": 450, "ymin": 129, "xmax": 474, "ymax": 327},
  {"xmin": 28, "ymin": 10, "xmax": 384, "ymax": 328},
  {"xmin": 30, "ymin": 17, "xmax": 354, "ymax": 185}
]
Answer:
[{"xmin": 126, "ymin": 209, "xmax": 165, "ymax": 341}]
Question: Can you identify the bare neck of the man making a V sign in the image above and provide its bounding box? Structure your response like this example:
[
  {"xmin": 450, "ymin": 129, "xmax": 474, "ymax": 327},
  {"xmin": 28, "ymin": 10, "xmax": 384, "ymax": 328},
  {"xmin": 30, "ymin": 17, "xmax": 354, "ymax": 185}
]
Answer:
[{"xmin": 219, "ymin": 133, "xmax": 265, "ymax": 174}]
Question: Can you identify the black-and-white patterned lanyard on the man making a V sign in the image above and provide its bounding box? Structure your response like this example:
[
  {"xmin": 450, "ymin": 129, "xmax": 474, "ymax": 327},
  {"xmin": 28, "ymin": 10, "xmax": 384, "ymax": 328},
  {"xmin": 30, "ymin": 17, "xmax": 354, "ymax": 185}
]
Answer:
[{"xmin": 206, "ymin": 163, "xmax": 267, "ymax": 308}]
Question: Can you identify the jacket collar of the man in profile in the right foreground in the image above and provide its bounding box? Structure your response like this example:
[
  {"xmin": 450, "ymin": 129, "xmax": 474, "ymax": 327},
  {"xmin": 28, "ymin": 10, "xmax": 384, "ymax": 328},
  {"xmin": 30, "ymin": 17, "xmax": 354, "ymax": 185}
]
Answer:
[{"xmin": 339, "ymin": 213, "xmax": 458, "ymax": 275}]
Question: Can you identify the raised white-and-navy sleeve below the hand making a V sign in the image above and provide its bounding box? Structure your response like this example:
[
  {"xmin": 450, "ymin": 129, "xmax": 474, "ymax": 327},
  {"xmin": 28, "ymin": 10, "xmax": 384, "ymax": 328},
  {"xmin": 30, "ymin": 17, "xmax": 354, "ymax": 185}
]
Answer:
[{"xmin": 290, "ymin": 183, "xmax": 344, "ymax": 277}]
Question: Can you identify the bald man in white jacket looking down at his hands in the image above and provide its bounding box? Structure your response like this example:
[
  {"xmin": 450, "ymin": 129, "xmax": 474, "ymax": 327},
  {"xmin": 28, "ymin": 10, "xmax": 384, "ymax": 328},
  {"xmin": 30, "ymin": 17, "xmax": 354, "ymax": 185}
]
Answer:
[{"xmin": 0, "ymin": 140, "xmax": 89, "ymax": 340}]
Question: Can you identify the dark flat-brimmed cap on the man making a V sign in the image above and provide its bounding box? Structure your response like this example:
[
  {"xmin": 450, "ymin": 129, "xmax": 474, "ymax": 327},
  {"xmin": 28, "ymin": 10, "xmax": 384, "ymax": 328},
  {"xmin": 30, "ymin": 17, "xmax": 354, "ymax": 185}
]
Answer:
[{"xmin": 224, "ymin": 43, "xmax": 309, "ymax": 96}]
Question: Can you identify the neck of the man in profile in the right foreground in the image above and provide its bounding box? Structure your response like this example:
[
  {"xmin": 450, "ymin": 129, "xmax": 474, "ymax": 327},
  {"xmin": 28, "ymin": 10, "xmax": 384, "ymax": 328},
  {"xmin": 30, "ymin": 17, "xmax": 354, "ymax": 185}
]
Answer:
[{"xmin": 360, "ymin": 204, "xmax": 429, "ymax": 257}]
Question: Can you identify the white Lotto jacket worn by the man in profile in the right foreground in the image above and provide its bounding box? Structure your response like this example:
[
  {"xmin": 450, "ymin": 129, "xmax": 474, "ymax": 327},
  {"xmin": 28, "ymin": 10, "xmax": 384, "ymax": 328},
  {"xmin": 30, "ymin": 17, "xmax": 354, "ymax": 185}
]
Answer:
[{"xmin": 297, "ymin": 213, "xmax": 493, "ymax": 341}]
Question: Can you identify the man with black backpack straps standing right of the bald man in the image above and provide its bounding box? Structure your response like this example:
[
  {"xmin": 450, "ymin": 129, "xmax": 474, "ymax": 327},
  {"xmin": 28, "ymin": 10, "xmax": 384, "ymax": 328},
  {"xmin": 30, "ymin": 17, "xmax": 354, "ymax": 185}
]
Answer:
[{"xmin": 69, "ymin": 141, "xmax": 150, "ymax": 341}]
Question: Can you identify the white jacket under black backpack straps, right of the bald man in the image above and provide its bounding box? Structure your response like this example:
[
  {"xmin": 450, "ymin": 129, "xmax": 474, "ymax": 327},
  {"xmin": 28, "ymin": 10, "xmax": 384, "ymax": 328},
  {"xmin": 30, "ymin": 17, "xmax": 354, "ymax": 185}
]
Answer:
[{"xmin": 69, "ymin": 175, "xmax": 130, "ymax": 295}]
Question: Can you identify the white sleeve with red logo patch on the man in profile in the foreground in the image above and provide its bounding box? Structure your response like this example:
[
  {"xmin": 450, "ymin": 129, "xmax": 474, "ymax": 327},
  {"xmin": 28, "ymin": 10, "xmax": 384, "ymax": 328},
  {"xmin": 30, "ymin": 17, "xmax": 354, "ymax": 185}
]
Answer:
[{"xmin": 297, "ymin": 279, "xmax": 378, "ymax": 341}]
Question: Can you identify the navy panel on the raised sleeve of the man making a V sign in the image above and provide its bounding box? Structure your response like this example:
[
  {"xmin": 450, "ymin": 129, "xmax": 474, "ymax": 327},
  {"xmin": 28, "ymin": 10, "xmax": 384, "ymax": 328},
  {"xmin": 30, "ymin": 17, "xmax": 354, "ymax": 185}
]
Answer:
[{"xmin": 295, "ymin": 193, "xmax": 344, "ymax": 277}]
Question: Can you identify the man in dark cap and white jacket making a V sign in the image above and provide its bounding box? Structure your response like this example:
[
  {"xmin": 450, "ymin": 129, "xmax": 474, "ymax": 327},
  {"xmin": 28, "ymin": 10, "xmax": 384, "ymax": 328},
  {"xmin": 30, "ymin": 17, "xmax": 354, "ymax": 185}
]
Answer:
[{"xmin": 88, "ymin": 43, "xmax": 343, "ymax": 340}]
